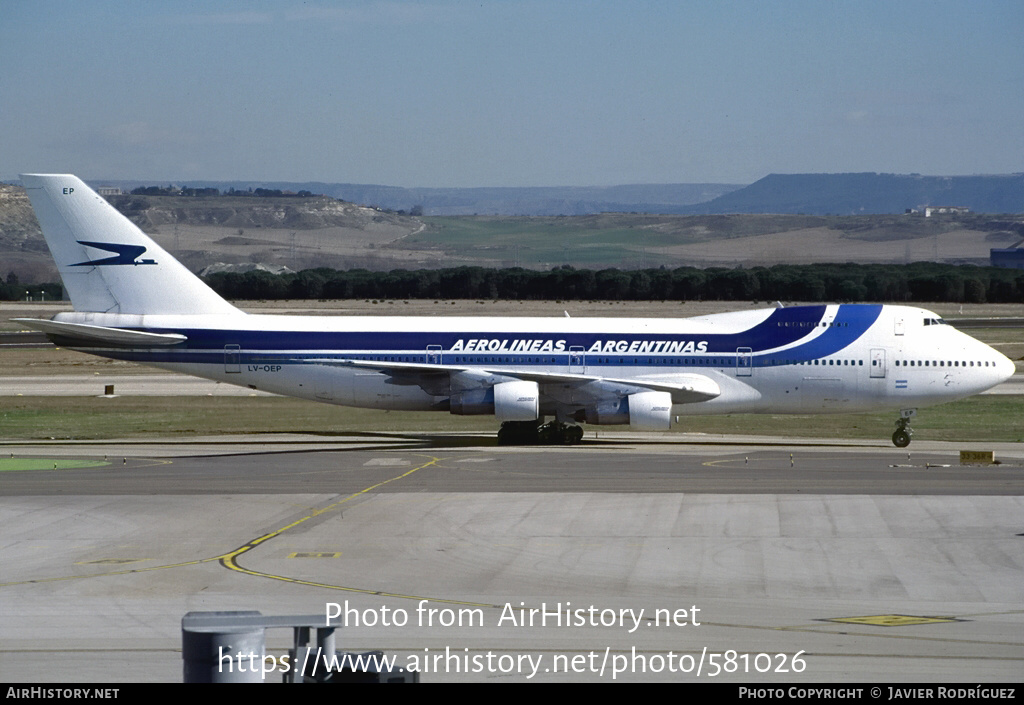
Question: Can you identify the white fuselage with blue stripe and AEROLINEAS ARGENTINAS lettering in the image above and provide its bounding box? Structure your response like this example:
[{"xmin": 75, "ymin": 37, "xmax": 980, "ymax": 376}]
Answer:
[{"xmin": 55, "ymin": 305, "xmax": 1014, "ymax": 422}]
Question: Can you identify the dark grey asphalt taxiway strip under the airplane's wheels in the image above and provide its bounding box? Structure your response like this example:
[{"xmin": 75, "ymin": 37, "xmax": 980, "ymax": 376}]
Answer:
[{"xmin": 0, "ymin": 432, "xmax": 1024, "ymax": 497}]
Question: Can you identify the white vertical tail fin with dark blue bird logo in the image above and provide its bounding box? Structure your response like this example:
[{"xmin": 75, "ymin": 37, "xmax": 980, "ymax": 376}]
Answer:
[{"xmin": 22, "ymin": 174, "xmax": 241, "ymax": 315}]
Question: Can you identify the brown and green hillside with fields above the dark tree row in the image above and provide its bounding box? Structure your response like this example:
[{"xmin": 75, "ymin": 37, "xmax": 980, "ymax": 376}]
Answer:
[{"xmin": 0, "ymin": 179, "xmax": 1024, "ymax": 284}]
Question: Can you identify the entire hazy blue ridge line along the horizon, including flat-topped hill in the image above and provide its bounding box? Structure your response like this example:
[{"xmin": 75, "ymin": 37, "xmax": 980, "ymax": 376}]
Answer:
[{"xmin": 9, "ymin": 172, "xmax": 1024, "ymax": 216}]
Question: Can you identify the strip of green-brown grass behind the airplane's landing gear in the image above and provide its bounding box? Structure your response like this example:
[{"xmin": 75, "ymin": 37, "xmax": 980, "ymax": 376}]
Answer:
[{"xmin": 0, "ymin": 395, "xmax": 1024, "ymax": 442}]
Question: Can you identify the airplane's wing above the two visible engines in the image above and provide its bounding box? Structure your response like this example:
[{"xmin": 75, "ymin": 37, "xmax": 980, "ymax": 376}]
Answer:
[{"xmin": 306, "ymin": 360, "xmax": 722, "ymax": 404}]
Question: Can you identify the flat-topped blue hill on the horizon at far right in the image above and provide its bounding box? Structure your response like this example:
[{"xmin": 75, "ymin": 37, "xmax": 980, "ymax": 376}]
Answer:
[{"xmin": 673, "ymin": 173, "xmax": 1024, "ymax": 215}]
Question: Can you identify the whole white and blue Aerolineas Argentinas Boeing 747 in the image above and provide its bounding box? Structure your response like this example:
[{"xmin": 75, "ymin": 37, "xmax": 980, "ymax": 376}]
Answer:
[{"xmin": 18, "ymin": 174, "xmax": 1014, "ymax": 448}]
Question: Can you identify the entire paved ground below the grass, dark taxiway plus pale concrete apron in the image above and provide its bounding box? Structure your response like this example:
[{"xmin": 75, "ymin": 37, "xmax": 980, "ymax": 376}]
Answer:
[{"xmin": 0, "ymin": 433, "xmax": 1024, "ymax": 682}]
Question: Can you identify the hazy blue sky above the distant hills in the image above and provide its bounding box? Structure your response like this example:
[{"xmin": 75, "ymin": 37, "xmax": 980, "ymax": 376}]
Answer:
[{"xmin": 0, "ymin": 0, "xmax": 1024, "ymax": 188}]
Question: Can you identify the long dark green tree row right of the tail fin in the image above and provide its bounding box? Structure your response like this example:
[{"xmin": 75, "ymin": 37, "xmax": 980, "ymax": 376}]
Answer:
[{"xmin": 199, "ymin": 262, "xmax": 1024, "ymax": 303}]
